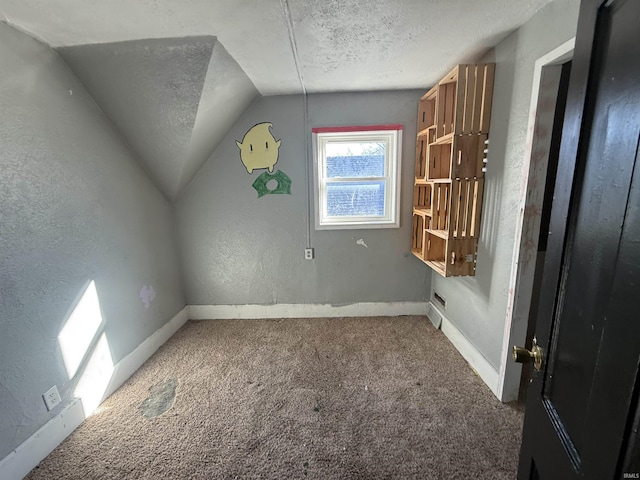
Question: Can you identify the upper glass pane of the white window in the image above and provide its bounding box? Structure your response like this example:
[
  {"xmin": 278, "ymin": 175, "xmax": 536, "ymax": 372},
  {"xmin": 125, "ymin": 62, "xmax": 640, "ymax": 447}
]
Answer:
[{"xmin": 325, "ymin": 141, "xmax": 386, "ymax": 178}]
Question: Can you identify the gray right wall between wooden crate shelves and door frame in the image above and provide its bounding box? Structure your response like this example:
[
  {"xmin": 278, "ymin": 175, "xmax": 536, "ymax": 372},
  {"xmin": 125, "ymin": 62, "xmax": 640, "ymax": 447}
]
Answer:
[{"xmin": 432, "ymin": 0, "xmax": 580, "ymax": 369}]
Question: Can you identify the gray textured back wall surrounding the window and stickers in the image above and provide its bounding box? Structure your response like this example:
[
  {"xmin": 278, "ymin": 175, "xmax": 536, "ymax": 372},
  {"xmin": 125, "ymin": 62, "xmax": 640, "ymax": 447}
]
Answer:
[{"xmin": 176, "ymin": 91, "xmax": 431, "ymax": 305}]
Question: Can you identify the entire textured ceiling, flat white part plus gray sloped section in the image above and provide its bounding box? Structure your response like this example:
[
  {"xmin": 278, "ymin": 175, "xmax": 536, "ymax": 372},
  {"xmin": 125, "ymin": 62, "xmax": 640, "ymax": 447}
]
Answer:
[{"xmin": 0, "ymin": 0, "xmax": 552, "ymax": 200}]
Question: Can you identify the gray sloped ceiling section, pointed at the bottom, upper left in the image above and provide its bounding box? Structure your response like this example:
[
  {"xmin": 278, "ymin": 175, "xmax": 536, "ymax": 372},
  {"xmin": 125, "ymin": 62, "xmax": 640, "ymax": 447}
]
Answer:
[{"xmin": 58, "ymin": 36, "xmax": 258, "ymax": 200}]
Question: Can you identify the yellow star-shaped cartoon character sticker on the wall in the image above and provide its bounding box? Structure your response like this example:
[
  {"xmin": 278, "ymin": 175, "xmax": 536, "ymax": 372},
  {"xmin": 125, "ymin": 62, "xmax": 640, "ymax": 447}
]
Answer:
[{"xmin": 236, "ymin": 122, "xmax": 282, "ymax": 173}]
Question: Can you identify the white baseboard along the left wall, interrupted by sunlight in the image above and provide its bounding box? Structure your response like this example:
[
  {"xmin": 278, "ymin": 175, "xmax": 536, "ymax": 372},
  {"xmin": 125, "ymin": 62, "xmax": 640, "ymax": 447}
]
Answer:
[{"xmin": 0, "ymin": 307, "xmax": 188, "ymax": 480}]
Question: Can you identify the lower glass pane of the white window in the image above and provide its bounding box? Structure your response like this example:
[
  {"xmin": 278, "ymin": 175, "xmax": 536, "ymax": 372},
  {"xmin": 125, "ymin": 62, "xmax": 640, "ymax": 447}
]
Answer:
[{"xmin": 327, "ymin": 181, "xmax": 385, "ymax": 217}]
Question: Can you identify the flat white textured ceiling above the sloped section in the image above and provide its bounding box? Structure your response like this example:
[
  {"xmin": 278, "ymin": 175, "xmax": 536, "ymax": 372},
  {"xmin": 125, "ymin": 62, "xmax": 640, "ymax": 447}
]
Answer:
[{"xmin": 0, "ymin": 0, "xmax": 562, "ymax": 95}]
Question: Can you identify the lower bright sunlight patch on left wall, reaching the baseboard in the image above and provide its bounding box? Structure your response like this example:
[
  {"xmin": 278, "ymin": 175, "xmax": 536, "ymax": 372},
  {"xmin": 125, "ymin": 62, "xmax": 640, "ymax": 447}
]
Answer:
[{"xmin": 73, "ymin": 333, "xmax": 114, "ymax": 417}]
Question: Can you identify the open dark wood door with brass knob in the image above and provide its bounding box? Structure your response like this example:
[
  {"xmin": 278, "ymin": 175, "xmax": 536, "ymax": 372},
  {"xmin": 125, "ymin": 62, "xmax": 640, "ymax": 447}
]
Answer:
[{"xmin": 518, "ymin": 0, "xmax": 640, "ymax": 480}]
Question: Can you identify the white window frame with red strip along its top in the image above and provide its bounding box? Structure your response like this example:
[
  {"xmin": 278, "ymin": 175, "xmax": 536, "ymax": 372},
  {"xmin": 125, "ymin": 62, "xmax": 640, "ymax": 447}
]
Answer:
[{"xmin": 312, "ymin": 125, "xmax": 402, "ymax": 230}]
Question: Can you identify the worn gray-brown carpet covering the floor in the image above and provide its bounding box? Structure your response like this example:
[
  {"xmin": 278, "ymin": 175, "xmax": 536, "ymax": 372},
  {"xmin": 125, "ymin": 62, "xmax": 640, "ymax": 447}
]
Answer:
[{"xmin": 26, "ymin": 316, "xmax": 523, "ymax": 480}]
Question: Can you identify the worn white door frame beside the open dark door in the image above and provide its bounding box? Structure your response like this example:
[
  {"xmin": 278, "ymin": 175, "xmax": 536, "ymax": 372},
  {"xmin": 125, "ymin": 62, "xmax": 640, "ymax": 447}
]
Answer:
[{"xmin": 497, "ymin": 37, "xmax": 575, "ymax": 402}]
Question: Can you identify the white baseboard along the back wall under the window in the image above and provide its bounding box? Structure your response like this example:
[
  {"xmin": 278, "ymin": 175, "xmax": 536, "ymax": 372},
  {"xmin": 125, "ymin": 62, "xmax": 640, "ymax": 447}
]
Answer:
[{"xmin": 189, "ymin": 302, "xmax": 427, "ymax": 320}]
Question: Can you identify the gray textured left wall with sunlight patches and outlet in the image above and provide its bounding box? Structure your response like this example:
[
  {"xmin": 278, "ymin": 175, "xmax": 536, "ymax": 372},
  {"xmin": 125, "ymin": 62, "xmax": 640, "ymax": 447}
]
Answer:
[{"xmin": 0, "ymin": 23, "xmax": 185, "ymax": 459}]
